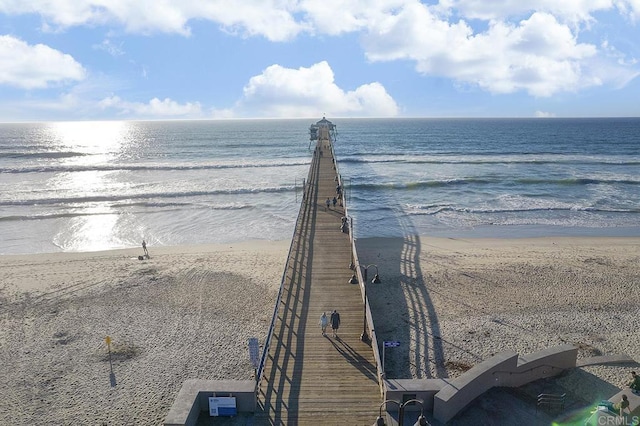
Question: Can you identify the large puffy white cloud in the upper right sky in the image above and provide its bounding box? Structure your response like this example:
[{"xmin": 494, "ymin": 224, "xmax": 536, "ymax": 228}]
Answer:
[{"xmin": 365, "ymin": 5, "xmax": 607, "ymax": 96}]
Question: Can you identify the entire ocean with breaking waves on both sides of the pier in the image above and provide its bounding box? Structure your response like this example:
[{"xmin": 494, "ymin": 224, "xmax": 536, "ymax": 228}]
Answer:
[{"xmin": 0, "ymin": 117, "xmax": 640, "ymax": 254}]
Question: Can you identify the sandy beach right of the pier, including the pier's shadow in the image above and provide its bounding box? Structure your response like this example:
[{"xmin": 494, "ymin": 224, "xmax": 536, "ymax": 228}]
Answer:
[{"xmin": 357, "ymin": 237, "xmax": 640, "ymax": 410}]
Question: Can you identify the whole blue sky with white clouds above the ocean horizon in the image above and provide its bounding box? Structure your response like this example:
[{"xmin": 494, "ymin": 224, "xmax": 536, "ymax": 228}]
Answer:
[{"xmin": 0, "ymin": 0, "xmax": 640, "ymax": 122}]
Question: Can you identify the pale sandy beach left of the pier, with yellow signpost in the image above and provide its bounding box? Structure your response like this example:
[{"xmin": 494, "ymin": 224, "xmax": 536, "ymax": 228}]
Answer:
[{"xmin": 0, "ymin": 242, "xmax": 289, "ymax": 425}]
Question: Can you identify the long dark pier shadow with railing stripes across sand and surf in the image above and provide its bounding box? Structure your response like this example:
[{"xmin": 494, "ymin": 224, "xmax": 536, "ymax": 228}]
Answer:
[{"xmin": 356, "ymin": 185, "xmax": 448, "ymax": 379}]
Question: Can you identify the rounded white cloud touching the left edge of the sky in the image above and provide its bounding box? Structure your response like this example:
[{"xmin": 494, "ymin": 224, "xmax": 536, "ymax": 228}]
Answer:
[{"xmin": 0, "ymin": 35, "xmax": 86, "ymax": 89}]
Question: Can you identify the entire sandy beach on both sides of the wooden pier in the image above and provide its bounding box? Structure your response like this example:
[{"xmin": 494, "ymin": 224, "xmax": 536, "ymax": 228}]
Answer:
[{"xmin": 0, "ymin": 237, "xmax": 640, "ymax": 425}]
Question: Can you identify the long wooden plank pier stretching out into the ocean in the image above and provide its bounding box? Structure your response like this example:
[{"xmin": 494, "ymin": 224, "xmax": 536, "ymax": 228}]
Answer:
[{"xmin": 254, "ymin": 125, "xmax": 382, "ymax": 425}]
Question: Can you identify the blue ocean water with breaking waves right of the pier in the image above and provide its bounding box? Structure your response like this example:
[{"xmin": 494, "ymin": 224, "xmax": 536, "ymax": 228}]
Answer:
[{"xmin": 338, "ymin": 118, "xmax": 640, "ymax": 237}]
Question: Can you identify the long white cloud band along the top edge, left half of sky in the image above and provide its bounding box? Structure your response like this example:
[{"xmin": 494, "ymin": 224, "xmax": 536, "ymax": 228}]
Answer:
[{"xmin": 0, "ymin": 0, "xmax": 309, "ymax": 41}]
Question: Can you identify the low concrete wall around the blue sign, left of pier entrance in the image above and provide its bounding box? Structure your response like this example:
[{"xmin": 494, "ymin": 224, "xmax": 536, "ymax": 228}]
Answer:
[{"xmin": 164, "ymin": 379, "xmax": 257, "ymax": 426}]
